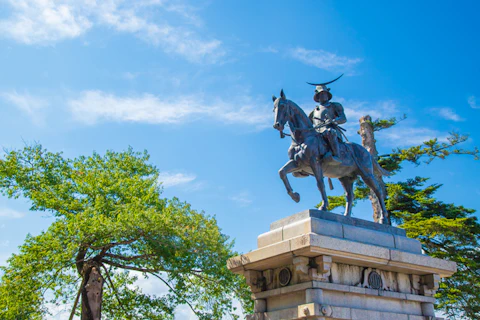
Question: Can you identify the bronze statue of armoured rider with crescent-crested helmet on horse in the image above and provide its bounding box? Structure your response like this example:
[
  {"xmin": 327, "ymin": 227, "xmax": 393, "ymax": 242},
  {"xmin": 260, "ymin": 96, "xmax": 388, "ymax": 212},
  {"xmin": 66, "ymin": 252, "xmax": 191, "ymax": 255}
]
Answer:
[{"xmin": 272, "ymin": 76, "xmax": 389, "ymax": 223}]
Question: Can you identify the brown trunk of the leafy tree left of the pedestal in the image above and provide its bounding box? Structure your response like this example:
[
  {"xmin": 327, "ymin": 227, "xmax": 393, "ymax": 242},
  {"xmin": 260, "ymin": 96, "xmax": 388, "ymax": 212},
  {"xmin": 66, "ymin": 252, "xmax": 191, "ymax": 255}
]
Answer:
[{"xmin": 81, "ymin": 262, "xmax": 104, "ymax": 320}]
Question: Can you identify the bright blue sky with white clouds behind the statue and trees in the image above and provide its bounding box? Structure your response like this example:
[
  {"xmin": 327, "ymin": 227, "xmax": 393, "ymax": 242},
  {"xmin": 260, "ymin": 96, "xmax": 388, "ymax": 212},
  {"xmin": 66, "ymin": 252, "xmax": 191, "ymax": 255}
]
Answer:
[{"xmin": 0, "ymin": 0, "xmax": 480, "ymax": 318}]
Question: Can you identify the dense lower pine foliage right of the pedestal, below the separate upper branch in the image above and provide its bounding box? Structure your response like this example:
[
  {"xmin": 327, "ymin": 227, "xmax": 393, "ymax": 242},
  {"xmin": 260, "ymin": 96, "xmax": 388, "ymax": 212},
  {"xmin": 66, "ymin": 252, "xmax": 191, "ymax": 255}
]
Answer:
[{"xmin": 386, "ymin": 177, "xmax": 480, "ymax": 319}]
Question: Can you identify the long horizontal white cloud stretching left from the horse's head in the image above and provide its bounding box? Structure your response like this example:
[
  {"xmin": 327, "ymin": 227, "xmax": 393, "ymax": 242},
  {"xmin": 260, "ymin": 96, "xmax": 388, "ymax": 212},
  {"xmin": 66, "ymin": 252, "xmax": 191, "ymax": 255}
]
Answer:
[{"xmin": 68, "ymin": 91, "xmax": 272, "ymax": 129}]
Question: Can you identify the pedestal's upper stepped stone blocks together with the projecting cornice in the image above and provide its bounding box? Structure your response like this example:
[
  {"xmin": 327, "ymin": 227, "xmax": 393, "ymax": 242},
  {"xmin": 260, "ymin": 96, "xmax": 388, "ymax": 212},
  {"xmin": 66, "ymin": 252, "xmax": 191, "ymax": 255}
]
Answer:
[{"xmin": 227, "ymin": 210, "xmax": 457, "ymax": 277}]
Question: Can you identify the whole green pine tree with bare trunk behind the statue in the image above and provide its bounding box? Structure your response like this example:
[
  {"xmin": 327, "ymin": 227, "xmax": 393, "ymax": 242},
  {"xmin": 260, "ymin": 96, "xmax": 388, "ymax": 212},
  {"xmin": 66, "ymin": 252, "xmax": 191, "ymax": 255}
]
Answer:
[{"xmin": 322, "ymin": 116, "xmax": 480, "ymax": 319}]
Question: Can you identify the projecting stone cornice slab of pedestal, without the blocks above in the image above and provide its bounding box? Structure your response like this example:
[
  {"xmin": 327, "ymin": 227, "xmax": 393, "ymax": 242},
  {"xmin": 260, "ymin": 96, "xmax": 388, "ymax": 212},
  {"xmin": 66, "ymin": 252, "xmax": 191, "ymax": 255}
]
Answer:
[{"xmin": 227, "ymin": 233, "xmax": 457, "ymax": 277}]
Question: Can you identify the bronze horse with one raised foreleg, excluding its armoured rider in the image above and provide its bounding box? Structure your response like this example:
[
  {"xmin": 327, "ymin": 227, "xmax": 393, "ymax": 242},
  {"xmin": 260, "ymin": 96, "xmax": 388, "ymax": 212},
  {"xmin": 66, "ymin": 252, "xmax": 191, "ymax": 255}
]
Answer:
[{"xmin": 272, "ymin": 89, "xmax": 389, "ymax": 224}]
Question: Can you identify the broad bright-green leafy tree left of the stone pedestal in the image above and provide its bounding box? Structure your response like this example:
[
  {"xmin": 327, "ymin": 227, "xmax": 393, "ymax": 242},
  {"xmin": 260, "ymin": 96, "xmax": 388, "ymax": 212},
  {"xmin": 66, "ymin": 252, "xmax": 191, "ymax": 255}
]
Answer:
[{"xmin": 0, "ymin": 145, "xmax": 251, "ymax": 320}]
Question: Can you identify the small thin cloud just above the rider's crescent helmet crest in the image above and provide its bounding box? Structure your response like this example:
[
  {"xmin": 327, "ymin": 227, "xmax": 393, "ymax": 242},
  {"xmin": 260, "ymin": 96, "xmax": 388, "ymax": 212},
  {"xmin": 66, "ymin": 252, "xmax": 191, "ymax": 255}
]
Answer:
[{"xmin": 289, "ymin": 47, "xmax": 363, "ymax": 73}]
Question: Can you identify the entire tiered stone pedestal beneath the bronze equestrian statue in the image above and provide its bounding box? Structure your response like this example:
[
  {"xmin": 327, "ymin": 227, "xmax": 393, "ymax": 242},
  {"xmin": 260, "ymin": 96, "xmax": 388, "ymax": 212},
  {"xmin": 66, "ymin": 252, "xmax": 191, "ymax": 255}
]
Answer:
[{"xmin": 228, "ymin": 210, "xmax": 456, "ymax": 320}]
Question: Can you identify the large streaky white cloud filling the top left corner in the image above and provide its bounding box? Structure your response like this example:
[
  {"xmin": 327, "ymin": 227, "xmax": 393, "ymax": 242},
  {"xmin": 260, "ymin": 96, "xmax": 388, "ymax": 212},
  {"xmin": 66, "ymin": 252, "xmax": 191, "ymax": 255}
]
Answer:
[{"xmin": 0, "ymin": 0, "xmax": 226, "ymax": 63}]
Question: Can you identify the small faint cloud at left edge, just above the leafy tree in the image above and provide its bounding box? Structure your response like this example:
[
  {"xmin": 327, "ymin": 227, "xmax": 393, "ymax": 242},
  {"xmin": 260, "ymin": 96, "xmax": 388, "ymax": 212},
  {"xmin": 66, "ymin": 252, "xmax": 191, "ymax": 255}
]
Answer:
[{"xmin": 0, "ymin": 90, "xmax": 48, "ymax": 123}]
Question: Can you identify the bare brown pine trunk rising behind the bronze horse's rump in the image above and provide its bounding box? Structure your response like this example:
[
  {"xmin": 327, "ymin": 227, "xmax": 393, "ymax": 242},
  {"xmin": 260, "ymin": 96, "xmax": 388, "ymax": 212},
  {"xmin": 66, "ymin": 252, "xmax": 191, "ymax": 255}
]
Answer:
[{"xmin": 358, "ymin": 115, "xmax": 391, "ymax": 224}]
